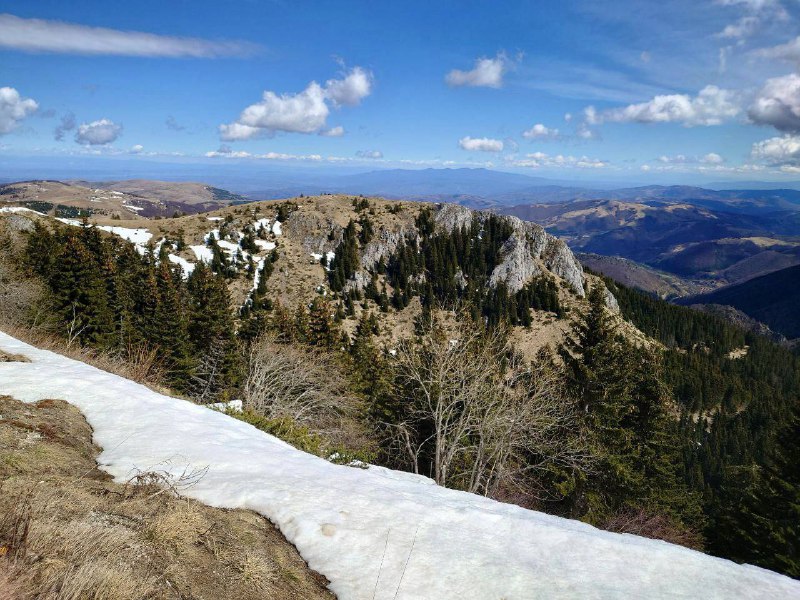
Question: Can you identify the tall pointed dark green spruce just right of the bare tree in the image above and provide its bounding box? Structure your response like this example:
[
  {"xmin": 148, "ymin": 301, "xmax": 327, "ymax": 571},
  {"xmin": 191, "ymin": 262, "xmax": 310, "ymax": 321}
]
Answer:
[{"xmin": 561, "ymin": 285, "xmax": 699, "ymax": 526}]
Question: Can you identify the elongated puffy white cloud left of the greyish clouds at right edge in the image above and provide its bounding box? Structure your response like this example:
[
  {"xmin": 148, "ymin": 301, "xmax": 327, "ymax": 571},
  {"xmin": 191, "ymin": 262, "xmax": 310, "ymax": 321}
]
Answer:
[{"xmin": 584, "ymin": 85, "xmax": 741, "ymax": 127}]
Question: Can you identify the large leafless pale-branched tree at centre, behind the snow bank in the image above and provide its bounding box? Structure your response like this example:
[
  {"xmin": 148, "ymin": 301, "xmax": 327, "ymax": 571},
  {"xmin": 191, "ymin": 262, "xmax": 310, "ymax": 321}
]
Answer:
[{"xmin": 386, "ymin": 319, "xmax": 588, "ymax": 495}]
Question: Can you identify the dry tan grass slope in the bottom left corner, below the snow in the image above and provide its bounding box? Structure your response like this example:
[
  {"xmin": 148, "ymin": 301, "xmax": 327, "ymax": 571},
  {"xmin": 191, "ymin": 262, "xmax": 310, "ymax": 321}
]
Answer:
[{"xmin": 0, "ymin": 397, "xmax": 332, "ymax": 600}]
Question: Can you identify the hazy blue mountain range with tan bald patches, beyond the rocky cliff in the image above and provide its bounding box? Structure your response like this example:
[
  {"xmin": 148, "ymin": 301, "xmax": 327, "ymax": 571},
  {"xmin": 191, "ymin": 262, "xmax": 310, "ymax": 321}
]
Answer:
[{"xmin": 499, "ymin": 199, "xmax": 800, "ymax": 286}]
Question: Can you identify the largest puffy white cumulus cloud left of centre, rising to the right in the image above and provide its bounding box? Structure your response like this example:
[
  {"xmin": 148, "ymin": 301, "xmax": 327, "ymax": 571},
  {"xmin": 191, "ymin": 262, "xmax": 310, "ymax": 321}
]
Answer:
[{"xmin": 219, "ymin": 67, "xmax": 372, "ymax": 141}]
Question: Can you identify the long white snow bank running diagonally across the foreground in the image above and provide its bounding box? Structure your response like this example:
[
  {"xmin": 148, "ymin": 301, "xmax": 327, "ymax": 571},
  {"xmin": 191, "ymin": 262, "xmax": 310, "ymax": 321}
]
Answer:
[{"xmin": 0, "ymin": 333, "xmax": 800, "ymax": 600}]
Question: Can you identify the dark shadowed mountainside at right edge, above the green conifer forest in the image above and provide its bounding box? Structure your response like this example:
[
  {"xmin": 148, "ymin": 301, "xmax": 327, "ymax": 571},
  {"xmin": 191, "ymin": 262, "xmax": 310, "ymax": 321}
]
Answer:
[{"xmin": 681, "ymin": 265, "xmax": 800, "ymax": 339}]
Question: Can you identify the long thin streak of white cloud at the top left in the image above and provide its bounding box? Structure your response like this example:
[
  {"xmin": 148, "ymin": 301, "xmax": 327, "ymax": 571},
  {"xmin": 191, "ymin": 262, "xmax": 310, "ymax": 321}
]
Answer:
[{"xmin": 0, "ymin": 14, "xmax": 258, "ymax": 58}]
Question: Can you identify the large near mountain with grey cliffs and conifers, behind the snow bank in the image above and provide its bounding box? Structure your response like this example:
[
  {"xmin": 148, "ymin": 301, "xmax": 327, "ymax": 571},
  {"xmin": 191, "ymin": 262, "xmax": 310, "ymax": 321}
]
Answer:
[{"xmin": 0, "ymin": 189, "xmax": 800, "ymax": 573}]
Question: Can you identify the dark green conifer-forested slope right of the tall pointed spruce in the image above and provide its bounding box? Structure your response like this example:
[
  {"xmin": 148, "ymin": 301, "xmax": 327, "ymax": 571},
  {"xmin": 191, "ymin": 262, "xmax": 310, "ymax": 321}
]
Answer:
[{"xmin": 607, "ymin": 274, "xmax": 800, "ymax": 572}]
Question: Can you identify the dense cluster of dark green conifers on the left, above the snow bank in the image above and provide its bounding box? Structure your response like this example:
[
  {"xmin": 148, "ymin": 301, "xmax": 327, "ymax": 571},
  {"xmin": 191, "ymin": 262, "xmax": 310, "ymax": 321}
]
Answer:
[{"xmin": 25, "ymin": 224, "xmax": 240, "ymax": 399}]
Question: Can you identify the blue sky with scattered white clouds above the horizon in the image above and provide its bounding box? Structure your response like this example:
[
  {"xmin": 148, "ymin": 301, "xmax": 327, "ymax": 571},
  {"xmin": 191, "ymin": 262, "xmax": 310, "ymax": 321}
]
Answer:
[{"xmin": 0, "ymin": 0, "xmax": 800, "ymax": 183}]
